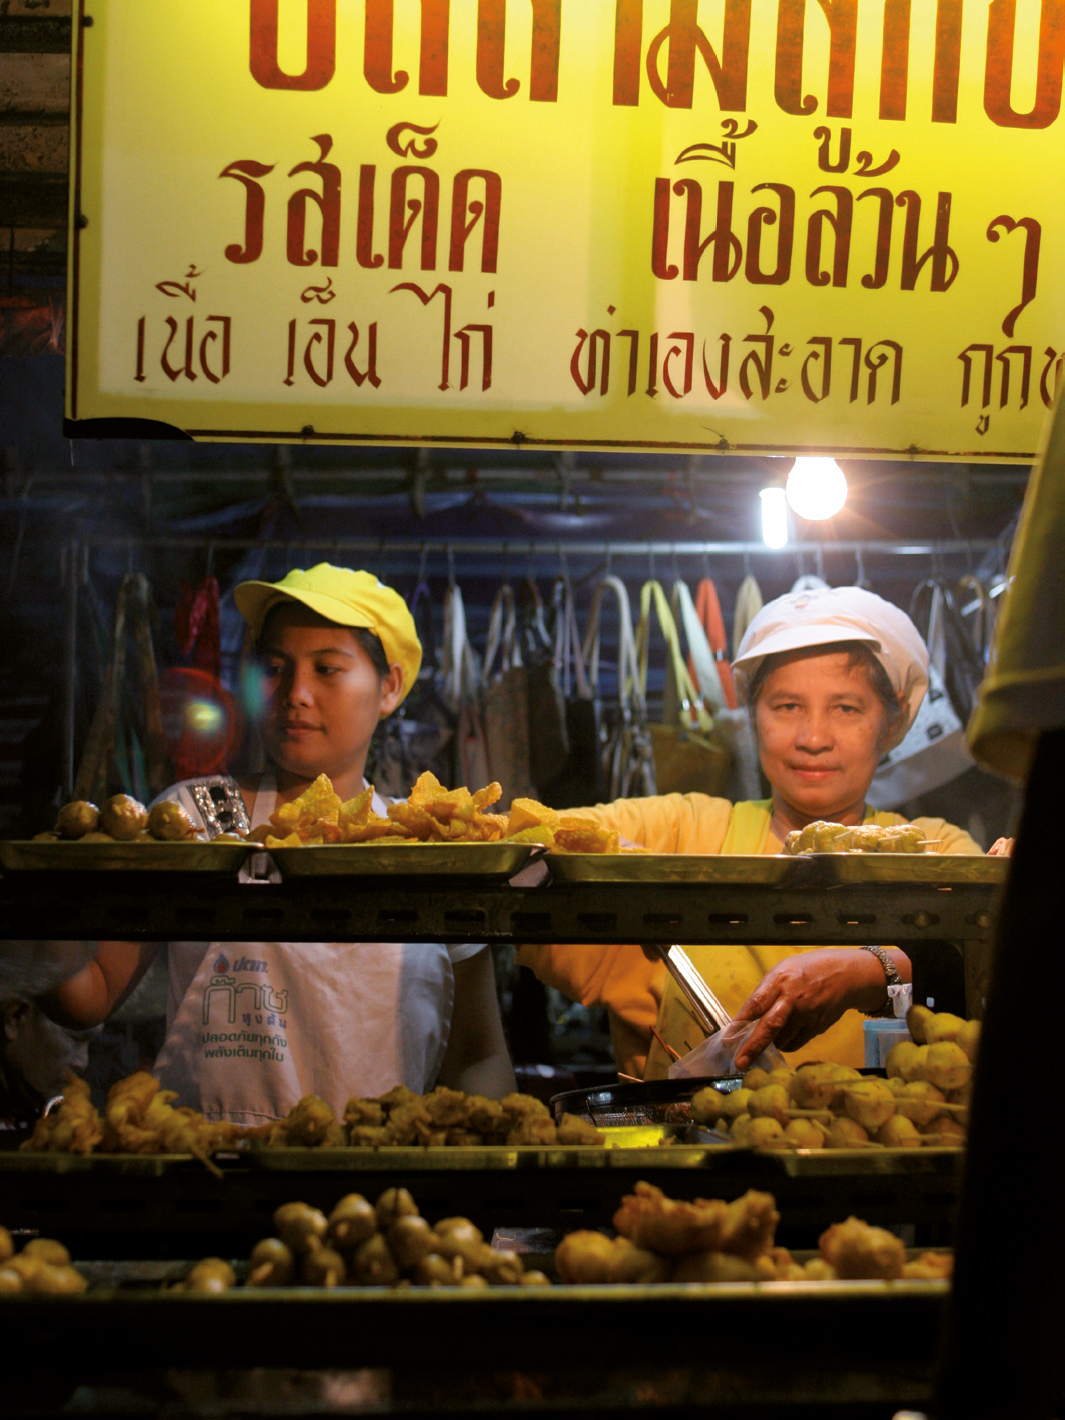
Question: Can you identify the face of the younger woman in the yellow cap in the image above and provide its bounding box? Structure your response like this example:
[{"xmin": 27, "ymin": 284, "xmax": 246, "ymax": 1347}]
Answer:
[{"xmin": 258, "ymin": 602, "xmax": 403, "ymax": 792}]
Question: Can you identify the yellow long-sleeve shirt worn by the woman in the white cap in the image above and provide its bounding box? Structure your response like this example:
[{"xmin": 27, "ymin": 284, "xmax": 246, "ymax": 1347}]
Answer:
[{"xmin": 518, "ymin": 794, "xmax": 981, "ymax": 1079}]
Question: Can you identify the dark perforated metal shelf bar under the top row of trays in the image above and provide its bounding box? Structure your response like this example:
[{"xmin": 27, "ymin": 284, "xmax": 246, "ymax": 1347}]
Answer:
[{"xmin": 0, "ymin": 872, "xmax": 1001, "ymax": 950}]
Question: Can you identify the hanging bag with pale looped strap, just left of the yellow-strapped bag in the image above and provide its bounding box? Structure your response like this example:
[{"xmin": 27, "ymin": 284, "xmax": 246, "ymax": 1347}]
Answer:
[{"xmin": 584, "ymin": 577, "xmax": 657, "ymax": 799}]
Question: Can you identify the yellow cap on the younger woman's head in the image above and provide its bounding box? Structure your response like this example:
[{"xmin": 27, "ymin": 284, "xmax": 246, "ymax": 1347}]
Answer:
[{"xmin": 233, "ymin": 562, "xmax": 422, "ymax": 696}]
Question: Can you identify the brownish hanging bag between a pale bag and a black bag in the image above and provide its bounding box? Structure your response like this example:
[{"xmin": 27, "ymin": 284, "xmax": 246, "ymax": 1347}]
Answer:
[{"xmin": 482, "ymin": 582, "xmax": 535, "ymax": 812}]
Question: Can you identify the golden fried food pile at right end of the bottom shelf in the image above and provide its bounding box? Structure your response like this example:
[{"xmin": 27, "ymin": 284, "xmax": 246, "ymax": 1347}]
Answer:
[{"xmin": 555, "ymin": 1183, "xmax": 953, "ymax": 1284}]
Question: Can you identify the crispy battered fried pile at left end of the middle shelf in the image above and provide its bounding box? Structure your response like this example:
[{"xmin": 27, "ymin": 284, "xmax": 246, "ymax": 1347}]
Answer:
[{"xmin": 21, "ymin": 1071, "xmax": 243, "ymax": 1172}]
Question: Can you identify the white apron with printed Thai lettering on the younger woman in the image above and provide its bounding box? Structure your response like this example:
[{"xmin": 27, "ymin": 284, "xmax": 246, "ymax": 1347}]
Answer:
[{"xmin": 155, "ymin": 774, "xmax": 481, "ymax": 1125}]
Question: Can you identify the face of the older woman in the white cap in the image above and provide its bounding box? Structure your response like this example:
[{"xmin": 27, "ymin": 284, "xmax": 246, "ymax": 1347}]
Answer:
[{"xmin": 754, "ymin": 652, "xmax": 886, "ymax": 819}]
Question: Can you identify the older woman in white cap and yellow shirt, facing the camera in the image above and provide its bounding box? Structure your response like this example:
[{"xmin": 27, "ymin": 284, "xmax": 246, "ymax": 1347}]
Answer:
[{"xmin": 518, "ymin": 586, "xmax": 980, "ymax": 1079}]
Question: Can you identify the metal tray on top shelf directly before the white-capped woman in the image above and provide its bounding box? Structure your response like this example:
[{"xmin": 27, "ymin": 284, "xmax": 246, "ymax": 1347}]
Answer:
[{"xmin": 547, "ymin": 853, "xmax": 1010, "ymax": 888}]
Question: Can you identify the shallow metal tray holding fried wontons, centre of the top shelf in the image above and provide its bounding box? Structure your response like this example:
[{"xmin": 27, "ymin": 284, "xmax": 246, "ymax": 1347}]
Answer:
[{"xmin": 267, "ymin": 842, "xmax": 538, "ymax": 879}]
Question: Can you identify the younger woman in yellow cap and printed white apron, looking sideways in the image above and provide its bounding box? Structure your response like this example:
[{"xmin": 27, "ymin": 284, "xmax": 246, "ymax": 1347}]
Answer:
[{"xmin": 45, "ymin": 562, "xmax": 514, "ymax": 1125}]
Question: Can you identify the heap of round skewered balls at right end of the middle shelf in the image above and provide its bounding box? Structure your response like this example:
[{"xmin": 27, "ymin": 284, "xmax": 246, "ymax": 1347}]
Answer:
[{"xmin": 692, "ymin": 1005, "xmax": 980, "ymax": 1149}]
